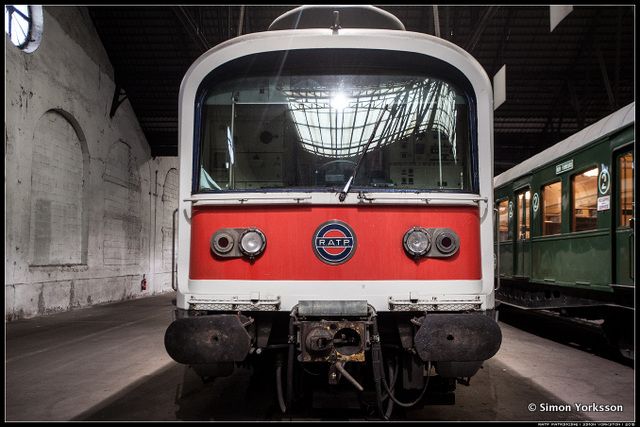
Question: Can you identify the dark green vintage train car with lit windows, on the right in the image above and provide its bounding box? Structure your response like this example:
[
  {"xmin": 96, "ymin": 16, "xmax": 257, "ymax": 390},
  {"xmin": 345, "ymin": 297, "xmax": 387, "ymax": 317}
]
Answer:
[{"xmin": 494, "ymin": 103, "xmax": 635, "ymax": 358}]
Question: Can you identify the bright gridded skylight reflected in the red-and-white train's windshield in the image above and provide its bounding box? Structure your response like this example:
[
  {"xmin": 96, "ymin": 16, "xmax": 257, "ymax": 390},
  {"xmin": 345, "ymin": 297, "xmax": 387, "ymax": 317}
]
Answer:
[{"xmin": 282, "ymin": 77, "xmax": 457, "ymax": 158}]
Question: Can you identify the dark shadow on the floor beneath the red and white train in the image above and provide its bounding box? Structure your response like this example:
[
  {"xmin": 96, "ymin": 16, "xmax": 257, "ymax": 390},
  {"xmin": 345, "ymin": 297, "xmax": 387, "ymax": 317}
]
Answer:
[{"xmin": 74, "ymin": 360, "xmax": 586, "ymax": 421}]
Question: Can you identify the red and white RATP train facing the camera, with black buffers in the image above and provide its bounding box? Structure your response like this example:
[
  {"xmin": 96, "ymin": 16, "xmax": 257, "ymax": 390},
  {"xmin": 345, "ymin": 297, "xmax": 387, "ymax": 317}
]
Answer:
[{"xmin": 165, "ymin": 6, "xmax": 501, "ymax": 417}]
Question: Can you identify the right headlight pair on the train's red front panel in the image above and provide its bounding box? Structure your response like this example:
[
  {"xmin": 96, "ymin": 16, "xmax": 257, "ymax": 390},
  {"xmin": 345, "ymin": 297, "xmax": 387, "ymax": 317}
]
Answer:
[{"xmin": 402, "ymin": 227, "xmax": 460, "ymax": 259}]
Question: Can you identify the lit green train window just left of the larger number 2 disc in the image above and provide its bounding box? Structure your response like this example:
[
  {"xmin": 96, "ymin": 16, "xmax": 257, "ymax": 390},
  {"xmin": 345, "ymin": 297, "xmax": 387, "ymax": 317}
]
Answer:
[{"xmin": 571, "ymin": 167, "xmax": 598, "ymax": 231}]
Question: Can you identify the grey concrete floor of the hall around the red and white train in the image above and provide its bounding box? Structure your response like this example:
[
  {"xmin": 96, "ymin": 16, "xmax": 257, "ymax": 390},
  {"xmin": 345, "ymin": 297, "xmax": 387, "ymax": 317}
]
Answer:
[{"xmin": 5, "ymin": 294, "xmax": 635, "ymax": 421}]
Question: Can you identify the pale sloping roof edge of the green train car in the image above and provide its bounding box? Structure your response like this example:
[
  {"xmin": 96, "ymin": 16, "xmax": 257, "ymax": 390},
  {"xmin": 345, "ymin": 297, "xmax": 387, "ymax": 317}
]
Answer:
[{"xmin": 493, "ymin": 102, "xmax": 636, "ymax": 188}]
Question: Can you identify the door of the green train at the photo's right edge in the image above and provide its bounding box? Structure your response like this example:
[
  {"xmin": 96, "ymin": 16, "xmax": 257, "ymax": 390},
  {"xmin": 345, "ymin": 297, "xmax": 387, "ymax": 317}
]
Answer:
[{"xmin": 613, "ymin": 148, "xmax": 635, "ymax": 286}]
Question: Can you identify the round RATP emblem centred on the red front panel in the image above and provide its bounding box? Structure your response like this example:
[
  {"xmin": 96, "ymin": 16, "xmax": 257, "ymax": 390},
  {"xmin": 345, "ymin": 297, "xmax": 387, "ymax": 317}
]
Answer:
[{"xmin": 312, "ymin": 219, "xmax": 356, "ymax": 265}]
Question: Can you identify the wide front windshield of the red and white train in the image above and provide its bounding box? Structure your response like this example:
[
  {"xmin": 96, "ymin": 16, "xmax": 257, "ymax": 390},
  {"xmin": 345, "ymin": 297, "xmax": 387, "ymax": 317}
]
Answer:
[{"xmin": 194, "ymin": 49, "xmax": 474, "ymax": 192}]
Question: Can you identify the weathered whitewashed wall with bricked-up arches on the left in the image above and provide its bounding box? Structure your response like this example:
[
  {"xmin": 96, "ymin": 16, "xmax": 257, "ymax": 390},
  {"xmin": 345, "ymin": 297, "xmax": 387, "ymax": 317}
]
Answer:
[{"xmin": 5, "ymin": 6, "xmax": 178, "ymax": 320}]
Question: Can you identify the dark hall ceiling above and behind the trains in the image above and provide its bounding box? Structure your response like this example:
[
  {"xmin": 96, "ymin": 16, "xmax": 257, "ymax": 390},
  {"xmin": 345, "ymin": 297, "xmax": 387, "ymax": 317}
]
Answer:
[{"xmin": 88, "ymin": 5, "xmax": 635, "ymax": 174}]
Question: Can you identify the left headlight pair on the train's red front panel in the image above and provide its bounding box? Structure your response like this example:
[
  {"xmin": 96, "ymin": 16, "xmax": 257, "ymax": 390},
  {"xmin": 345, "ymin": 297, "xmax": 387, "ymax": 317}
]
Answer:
[{"xmin": 211, "ymin": 228, "xmax": 267, "ymax": 259}]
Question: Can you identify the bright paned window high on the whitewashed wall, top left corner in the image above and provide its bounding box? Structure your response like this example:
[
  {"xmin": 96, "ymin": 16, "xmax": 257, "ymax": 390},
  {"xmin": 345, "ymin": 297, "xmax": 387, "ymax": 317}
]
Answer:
[{"xmin": 4, "ymin": 4, "xmax": 43, "ymax": 53}]
